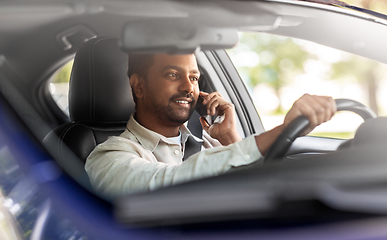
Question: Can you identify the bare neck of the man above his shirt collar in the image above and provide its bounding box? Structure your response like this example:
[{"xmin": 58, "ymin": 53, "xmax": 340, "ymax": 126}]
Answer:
[{"xmin": 134, "ymin": 112, "xmax": 181, "ymax": 137}]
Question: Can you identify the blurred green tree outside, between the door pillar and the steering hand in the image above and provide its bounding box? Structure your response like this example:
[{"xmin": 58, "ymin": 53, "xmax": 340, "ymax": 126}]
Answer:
[{"xmin": 229, "ymin": 33, "xmax": 313, "ymax": 113}]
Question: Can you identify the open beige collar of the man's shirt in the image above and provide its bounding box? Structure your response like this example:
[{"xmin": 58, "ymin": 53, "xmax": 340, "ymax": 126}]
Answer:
[{"xmin": 127, "ymin": 113, "xmax": 203, "ymax": 152}]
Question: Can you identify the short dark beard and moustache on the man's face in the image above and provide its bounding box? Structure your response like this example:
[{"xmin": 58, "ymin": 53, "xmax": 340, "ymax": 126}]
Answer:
[{"xmin": 148, "ymin": 93, "xmax": 196, "ymax": 126}]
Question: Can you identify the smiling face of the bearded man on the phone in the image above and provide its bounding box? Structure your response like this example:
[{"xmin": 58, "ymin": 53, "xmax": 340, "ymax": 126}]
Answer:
[{"xmin": 142, "ymin": 54, "xmax": 200, "ymax": 126}]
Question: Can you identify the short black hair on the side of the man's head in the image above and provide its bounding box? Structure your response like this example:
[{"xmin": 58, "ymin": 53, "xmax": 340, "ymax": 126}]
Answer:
[{"xmin": 128, "ymin": 53, "xmax": 154, "ymax": 103}]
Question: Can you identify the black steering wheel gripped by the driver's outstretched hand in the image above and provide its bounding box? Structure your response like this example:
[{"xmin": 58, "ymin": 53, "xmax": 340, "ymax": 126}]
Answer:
[{"xmin": 264, "ymin": 99, "xmax": 377, "ymax": 163}]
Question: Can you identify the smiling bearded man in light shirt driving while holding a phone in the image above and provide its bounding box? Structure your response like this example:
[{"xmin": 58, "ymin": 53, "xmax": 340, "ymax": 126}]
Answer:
[{"xmin": 85, "ymin": 54, "xmax": 336, "ymax": 197}]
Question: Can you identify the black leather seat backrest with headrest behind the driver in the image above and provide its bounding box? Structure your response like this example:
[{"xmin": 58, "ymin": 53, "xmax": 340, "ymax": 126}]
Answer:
[{"xmin": 44, "ymin": 37, "xmax": 135, "ymax": 162}]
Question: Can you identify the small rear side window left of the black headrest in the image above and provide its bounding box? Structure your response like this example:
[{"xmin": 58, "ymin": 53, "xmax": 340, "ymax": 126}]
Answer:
[{"xmin": 49, "ymin": 59, "xmax": 74, "ymax": 116}]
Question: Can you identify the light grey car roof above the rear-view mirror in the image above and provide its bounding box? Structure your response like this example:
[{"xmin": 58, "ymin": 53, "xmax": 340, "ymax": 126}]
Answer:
[{"xmin": 0, "ymin": 0, "xmax": 387, "ymax": 70}]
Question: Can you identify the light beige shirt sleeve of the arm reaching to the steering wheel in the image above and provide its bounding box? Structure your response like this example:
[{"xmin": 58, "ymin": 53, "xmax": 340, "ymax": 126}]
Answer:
[{"xmin": 85, "ymin": 136, "xmax": 262, "ymax": 198}]
